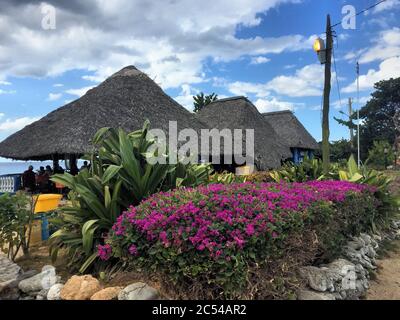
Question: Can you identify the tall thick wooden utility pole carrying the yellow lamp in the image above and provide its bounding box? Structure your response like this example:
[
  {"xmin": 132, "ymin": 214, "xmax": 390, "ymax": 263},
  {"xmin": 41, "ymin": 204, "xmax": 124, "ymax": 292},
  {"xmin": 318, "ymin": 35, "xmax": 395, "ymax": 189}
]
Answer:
[{"xmin": 322, "ymin": 14, "xmax": 333, "ymax": 174}]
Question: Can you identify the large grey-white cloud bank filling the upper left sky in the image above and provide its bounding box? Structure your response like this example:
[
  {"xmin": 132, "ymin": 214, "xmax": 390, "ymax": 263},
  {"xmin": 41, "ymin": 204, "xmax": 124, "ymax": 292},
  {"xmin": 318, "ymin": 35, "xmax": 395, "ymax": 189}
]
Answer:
[{"xmin": 0, "ymin": 0, "xmax": 314, "ymax": 89}]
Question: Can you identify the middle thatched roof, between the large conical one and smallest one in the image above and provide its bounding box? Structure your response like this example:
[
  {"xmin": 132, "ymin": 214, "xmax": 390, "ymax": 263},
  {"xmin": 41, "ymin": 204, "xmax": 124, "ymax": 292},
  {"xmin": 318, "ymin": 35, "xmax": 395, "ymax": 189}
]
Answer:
[{"xmin": 197, "ymin": 96, "xmax": 292, "ymax": 170}]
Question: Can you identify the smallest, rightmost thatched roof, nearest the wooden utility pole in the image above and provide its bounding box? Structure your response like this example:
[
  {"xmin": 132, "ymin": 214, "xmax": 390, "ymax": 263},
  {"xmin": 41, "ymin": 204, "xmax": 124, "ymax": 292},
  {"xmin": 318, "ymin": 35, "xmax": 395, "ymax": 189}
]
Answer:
[{"xmin": 263, "ymin": 110, "xmax": 319, "ymax": 150}]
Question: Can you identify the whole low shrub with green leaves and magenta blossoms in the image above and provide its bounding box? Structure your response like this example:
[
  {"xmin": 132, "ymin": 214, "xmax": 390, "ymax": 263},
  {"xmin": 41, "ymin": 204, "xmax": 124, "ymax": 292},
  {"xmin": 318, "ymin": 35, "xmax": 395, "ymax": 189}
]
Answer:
[{"xmin": 103, "ymin": 181, "xmax": 376, "ymax": 297}]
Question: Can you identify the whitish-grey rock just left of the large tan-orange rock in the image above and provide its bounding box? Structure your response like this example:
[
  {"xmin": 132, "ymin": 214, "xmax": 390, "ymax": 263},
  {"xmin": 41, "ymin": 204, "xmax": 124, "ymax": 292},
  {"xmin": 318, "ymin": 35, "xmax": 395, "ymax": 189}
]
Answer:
[{"xmin": 18, "ymin": 266, "xmax": 61, "ymax": 293}]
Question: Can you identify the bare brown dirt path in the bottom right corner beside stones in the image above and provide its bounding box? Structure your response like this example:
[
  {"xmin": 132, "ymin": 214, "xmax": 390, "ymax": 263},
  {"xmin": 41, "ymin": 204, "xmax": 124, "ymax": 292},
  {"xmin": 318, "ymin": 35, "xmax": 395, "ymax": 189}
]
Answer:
[{"xmin": 366, "ymin": 240, "xmax": 400, "ymax": 300}]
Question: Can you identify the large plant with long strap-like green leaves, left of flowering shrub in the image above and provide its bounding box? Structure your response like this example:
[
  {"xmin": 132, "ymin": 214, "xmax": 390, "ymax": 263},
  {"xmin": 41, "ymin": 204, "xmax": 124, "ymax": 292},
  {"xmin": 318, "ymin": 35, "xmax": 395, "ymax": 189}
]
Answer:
[{"xmin": 50, "ymin": 121, "xmax": 211, "ymax": 272}]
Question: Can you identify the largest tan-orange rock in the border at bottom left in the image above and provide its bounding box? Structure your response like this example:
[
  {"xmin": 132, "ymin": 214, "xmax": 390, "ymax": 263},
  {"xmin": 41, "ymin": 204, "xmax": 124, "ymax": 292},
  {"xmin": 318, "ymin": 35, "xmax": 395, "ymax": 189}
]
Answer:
[{"xmin": 61, "ymin": 275, "xmax": 101, "ymax": 300}]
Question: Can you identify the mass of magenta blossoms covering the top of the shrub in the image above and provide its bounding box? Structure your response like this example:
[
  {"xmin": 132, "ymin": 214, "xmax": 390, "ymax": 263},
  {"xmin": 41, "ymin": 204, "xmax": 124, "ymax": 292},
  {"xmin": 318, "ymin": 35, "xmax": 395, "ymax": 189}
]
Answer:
[{"xmin": 99, "ymin": 181, "xmax": 376, "ymax": 261}]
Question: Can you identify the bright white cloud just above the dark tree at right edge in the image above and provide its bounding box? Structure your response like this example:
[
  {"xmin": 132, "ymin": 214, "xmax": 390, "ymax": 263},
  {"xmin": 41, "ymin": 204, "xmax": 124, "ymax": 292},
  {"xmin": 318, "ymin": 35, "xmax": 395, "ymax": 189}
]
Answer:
[{"xmin": 342, "ymin": 57, "xmax": 400, "ymax": 93}]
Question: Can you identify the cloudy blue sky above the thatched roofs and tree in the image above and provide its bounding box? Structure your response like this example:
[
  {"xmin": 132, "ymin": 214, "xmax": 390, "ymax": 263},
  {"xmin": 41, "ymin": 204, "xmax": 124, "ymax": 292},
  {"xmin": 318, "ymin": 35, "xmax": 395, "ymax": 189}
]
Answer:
[{"xmin": 0, "ymin": 0, "xmax": 400, "ymax": 160}]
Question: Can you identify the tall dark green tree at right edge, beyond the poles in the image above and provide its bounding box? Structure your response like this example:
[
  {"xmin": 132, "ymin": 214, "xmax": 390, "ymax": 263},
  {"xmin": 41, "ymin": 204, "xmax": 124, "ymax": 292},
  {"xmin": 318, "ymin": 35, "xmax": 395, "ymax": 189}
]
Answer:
[{"xmin": 335, "ymin": 78, "xmax": 400, "ymax": 159}]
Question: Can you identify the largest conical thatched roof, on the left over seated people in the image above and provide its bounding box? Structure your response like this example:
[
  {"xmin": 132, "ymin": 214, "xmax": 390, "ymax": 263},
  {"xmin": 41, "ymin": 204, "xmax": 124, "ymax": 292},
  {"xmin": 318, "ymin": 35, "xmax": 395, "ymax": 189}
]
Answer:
[{"xmin": 0, "ymin": 66, "xmax": 205, "ymax": 160}]
